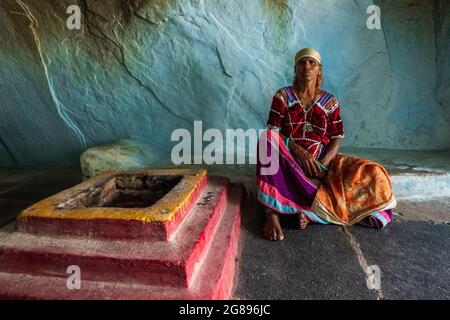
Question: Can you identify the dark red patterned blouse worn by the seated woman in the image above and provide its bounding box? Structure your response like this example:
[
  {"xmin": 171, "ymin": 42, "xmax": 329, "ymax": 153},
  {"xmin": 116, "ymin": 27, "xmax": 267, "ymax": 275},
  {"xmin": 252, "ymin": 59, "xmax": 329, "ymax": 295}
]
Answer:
[{"xmin": 267, "ymin": 87, "xmax": 344, "ymax": 158}]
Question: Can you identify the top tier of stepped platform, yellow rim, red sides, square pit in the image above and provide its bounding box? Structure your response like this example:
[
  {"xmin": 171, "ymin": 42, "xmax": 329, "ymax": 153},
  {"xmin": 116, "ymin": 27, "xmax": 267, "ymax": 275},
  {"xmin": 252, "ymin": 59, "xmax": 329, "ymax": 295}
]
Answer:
[{"xmin": 16, "ymin": 169, "xmax": 207, "ymax": 241}]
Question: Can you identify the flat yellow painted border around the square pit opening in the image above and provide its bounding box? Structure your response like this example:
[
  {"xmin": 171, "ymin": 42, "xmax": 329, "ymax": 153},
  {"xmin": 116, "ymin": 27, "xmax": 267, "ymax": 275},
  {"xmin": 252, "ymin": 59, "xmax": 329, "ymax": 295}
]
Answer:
[{"xmin": 18, "ymin": 169, "xmax": 207, "ymax": 222}]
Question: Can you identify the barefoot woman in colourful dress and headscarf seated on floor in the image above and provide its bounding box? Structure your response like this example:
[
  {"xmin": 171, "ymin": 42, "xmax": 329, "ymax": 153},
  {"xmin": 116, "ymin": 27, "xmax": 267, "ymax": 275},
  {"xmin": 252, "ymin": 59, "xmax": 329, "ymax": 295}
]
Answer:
[{"xmin": 257, "ymin": 48, "xmax": 396, "ymax": 240}]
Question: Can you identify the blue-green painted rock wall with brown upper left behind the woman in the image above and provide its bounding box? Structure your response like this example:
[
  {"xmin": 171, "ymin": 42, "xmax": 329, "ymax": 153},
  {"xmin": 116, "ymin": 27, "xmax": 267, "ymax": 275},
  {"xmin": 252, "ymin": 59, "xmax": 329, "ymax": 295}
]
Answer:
[{"xmin": 0, "ymin": 0, "xmax": 450, "ymax": 165}]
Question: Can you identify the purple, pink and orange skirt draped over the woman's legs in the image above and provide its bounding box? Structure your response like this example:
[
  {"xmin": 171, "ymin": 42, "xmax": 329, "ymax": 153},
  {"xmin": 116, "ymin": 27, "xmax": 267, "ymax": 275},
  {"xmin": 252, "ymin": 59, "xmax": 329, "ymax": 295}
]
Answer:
[{"xmin": 257, "ymin": 130, "xmax": 395, "ymax": 229}]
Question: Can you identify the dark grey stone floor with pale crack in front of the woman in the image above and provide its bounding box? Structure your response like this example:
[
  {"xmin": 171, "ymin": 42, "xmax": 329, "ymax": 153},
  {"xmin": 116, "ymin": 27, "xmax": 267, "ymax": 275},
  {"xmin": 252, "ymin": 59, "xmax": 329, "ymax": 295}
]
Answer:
[{"xmin": 234, "ymin": 199, "xmax": 450, "ymax": 300}]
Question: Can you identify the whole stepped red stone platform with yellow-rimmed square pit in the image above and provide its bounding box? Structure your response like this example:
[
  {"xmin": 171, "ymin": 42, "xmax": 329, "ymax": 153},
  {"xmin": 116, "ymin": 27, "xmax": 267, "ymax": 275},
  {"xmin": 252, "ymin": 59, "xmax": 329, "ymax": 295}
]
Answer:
[{"xmin": 0, "ymin": 169, "xmax": 243, "ymax": 299}]
